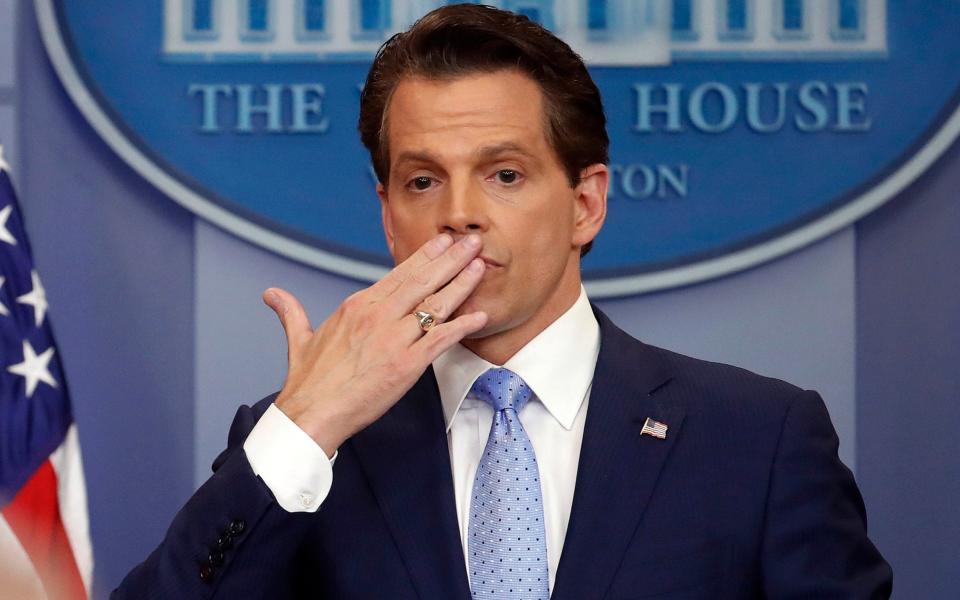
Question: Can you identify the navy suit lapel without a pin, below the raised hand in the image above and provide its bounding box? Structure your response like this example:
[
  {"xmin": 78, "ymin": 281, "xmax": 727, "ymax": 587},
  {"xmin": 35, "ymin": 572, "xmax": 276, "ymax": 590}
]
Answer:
[{"xmin": 352, "ymin": 367, "xmax": 470, "ymax": 598}]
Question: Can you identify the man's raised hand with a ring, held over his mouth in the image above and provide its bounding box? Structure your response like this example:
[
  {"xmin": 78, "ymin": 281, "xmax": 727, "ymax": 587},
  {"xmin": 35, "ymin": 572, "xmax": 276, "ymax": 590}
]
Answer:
[{"xmin": 263, "ymin": 234, "xmax": 487, "ymax": 456}]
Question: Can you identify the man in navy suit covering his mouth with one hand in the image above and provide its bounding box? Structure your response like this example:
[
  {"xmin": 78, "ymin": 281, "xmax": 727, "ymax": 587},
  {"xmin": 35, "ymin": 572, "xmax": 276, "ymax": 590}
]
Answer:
[{"xmin": 115, "ymin": 5, "xmax": 891, "ymax": 600}]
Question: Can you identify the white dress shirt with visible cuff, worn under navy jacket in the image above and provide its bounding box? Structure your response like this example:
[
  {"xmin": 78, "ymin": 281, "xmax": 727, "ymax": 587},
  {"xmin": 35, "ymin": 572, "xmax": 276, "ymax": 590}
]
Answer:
[{"xmin": 243, "ymin": 288, "xmax": 600, "ymax": 591}]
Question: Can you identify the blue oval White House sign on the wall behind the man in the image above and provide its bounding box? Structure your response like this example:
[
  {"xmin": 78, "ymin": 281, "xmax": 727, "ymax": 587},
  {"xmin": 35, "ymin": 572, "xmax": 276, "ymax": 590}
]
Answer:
[{"xmin": 30, "ymin": 0, "xmax": 960, "ymax": 297}]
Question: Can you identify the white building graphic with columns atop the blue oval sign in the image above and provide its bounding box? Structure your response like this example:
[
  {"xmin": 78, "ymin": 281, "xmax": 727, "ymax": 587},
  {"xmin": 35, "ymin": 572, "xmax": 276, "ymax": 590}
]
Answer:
[{"xmin": 163, "ymin": 0, "xmax": 886, "ymax": 65}]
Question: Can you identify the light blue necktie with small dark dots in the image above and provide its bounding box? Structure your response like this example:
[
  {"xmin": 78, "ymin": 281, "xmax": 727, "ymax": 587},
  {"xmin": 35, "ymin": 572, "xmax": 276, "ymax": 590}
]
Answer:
[{"xmin": 467, "ymin": 368, "xmax": 550, "ymax": 600}]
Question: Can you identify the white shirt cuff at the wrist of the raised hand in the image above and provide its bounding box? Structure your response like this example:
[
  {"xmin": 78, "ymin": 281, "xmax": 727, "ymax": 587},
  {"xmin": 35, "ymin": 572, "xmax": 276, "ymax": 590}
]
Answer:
[{"xmin": 243, "ymin": 404, "xmax": 337, "ymax": 512}]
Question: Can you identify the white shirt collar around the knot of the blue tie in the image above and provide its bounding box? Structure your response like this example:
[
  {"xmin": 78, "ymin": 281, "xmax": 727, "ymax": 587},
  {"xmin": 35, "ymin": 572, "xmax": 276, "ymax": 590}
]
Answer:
[{"xmin": 433, "ymin": 286, "xmax": 600, "ymax": 431}]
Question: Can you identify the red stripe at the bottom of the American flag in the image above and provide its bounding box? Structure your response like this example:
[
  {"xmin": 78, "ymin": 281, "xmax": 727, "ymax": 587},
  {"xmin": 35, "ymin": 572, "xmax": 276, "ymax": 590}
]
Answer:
[{"xmin": 3, "ymin": 460, "xmax": 87, "ymax": 600}]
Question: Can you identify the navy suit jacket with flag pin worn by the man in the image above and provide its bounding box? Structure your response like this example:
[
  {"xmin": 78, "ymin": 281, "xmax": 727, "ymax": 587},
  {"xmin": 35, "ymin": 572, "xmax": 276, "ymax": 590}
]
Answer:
[{"xmin": 114, "ymin": 311, "xmax": 892, "ymax": 600}]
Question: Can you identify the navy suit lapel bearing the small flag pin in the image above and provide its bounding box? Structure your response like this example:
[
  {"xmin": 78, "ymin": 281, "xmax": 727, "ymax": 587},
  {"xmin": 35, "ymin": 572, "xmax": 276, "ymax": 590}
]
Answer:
[{"xmin": 552, "ymin": 309, "xmax": 684, "ymax": 600}]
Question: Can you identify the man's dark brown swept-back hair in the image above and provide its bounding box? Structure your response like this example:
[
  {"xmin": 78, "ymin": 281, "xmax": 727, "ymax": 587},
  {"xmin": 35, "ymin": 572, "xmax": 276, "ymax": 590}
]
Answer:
[{"xmin": 359, "ymin": 4, "xmax": 610, "ymax": 254}]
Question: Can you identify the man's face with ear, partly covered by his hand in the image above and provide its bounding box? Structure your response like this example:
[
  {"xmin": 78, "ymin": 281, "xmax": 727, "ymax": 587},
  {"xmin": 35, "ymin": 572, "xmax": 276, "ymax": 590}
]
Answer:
[{"xmin": 378, "ymin": 70, "xmax": 606, "ymax": 337}]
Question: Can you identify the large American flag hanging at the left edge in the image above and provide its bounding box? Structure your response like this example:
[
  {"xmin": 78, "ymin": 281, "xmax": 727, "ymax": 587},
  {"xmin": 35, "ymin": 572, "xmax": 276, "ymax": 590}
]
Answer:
[{"xmin": 0, "ymin": 147, "xmax": 93, "ymax": 600}]
